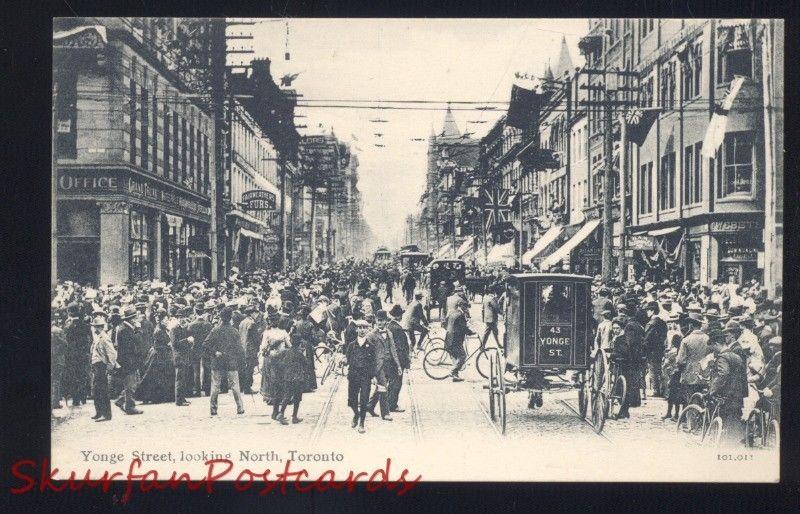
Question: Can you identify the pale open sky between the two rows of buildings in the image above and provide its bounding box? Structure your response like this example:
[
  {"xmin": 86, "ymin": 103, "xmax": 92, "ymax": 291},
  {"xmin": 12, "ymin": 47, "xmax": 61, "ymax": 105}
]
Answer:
[{"xmin": 245, "ymin": 18, "xmax": 587, "ymax": 248}]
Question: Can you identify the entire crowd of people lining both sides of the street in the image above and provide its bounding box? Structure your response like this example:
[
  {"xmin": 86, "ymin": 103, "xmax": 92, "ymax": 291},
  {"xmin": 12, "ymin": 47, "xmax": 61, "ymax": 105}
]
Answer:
[{"xmin": 52, "ymin": 259, "xmax": 782, "ymax": 442}]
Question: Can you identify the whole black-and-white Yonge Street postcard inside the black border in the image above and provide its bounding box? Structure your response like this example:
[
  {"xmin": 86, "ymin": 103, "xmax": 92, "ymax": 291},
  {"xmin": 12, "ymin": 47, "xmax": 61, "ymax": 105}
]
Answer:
[{"xmin": 48, "ymin": 17, "xmax": 789, "ymax": 485}]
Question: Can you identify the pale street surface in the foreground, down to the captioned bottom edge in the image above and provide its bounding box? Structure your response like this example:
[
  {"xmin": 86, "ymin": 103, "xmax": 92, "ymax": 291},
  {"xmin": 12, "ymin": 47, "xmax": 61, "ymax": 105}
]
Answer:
[{"xmin": 52, "ymin": 290, "xmax": 777, "ymax": 481}]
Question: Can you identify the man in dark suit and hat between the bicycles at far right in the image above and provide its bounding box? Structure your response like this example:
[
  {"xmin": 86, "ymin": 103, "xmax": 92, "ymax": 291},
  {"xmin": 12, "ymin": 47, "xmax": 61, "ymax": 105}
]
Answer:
[{"xmin": 708, "ymin": 321, "xmax": 747, "ymax": 444}]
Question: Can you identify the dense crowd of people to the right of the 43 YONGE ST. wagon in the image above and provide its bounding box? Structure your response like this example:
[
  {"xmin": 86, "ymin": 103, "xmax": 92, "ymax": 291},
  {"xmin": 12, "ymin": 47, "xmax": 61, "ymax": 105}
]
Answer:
[{"xmin": 593, "ymin": 280, "xmax": 782, "ymax": 440}]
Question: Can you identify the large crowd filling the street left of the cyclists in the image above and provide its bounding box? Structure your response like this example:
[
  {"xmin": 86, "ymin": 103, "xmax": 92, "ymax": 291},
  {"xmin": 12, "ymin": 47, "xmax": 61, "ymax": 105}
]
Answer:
[{"xmin": 51, "ymin": 260, "xmax": 426, "ymax": 432}]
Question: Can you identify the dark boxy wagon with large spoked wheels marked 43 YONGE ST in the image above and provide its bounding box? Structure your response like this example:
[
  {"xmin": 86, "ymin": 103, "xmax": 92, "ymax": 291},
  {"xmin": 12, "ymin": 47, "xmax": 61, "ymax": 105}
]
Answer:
[{"xmin": 487, "ymin": 273, "xmax": 624, "ymax": 434}]
